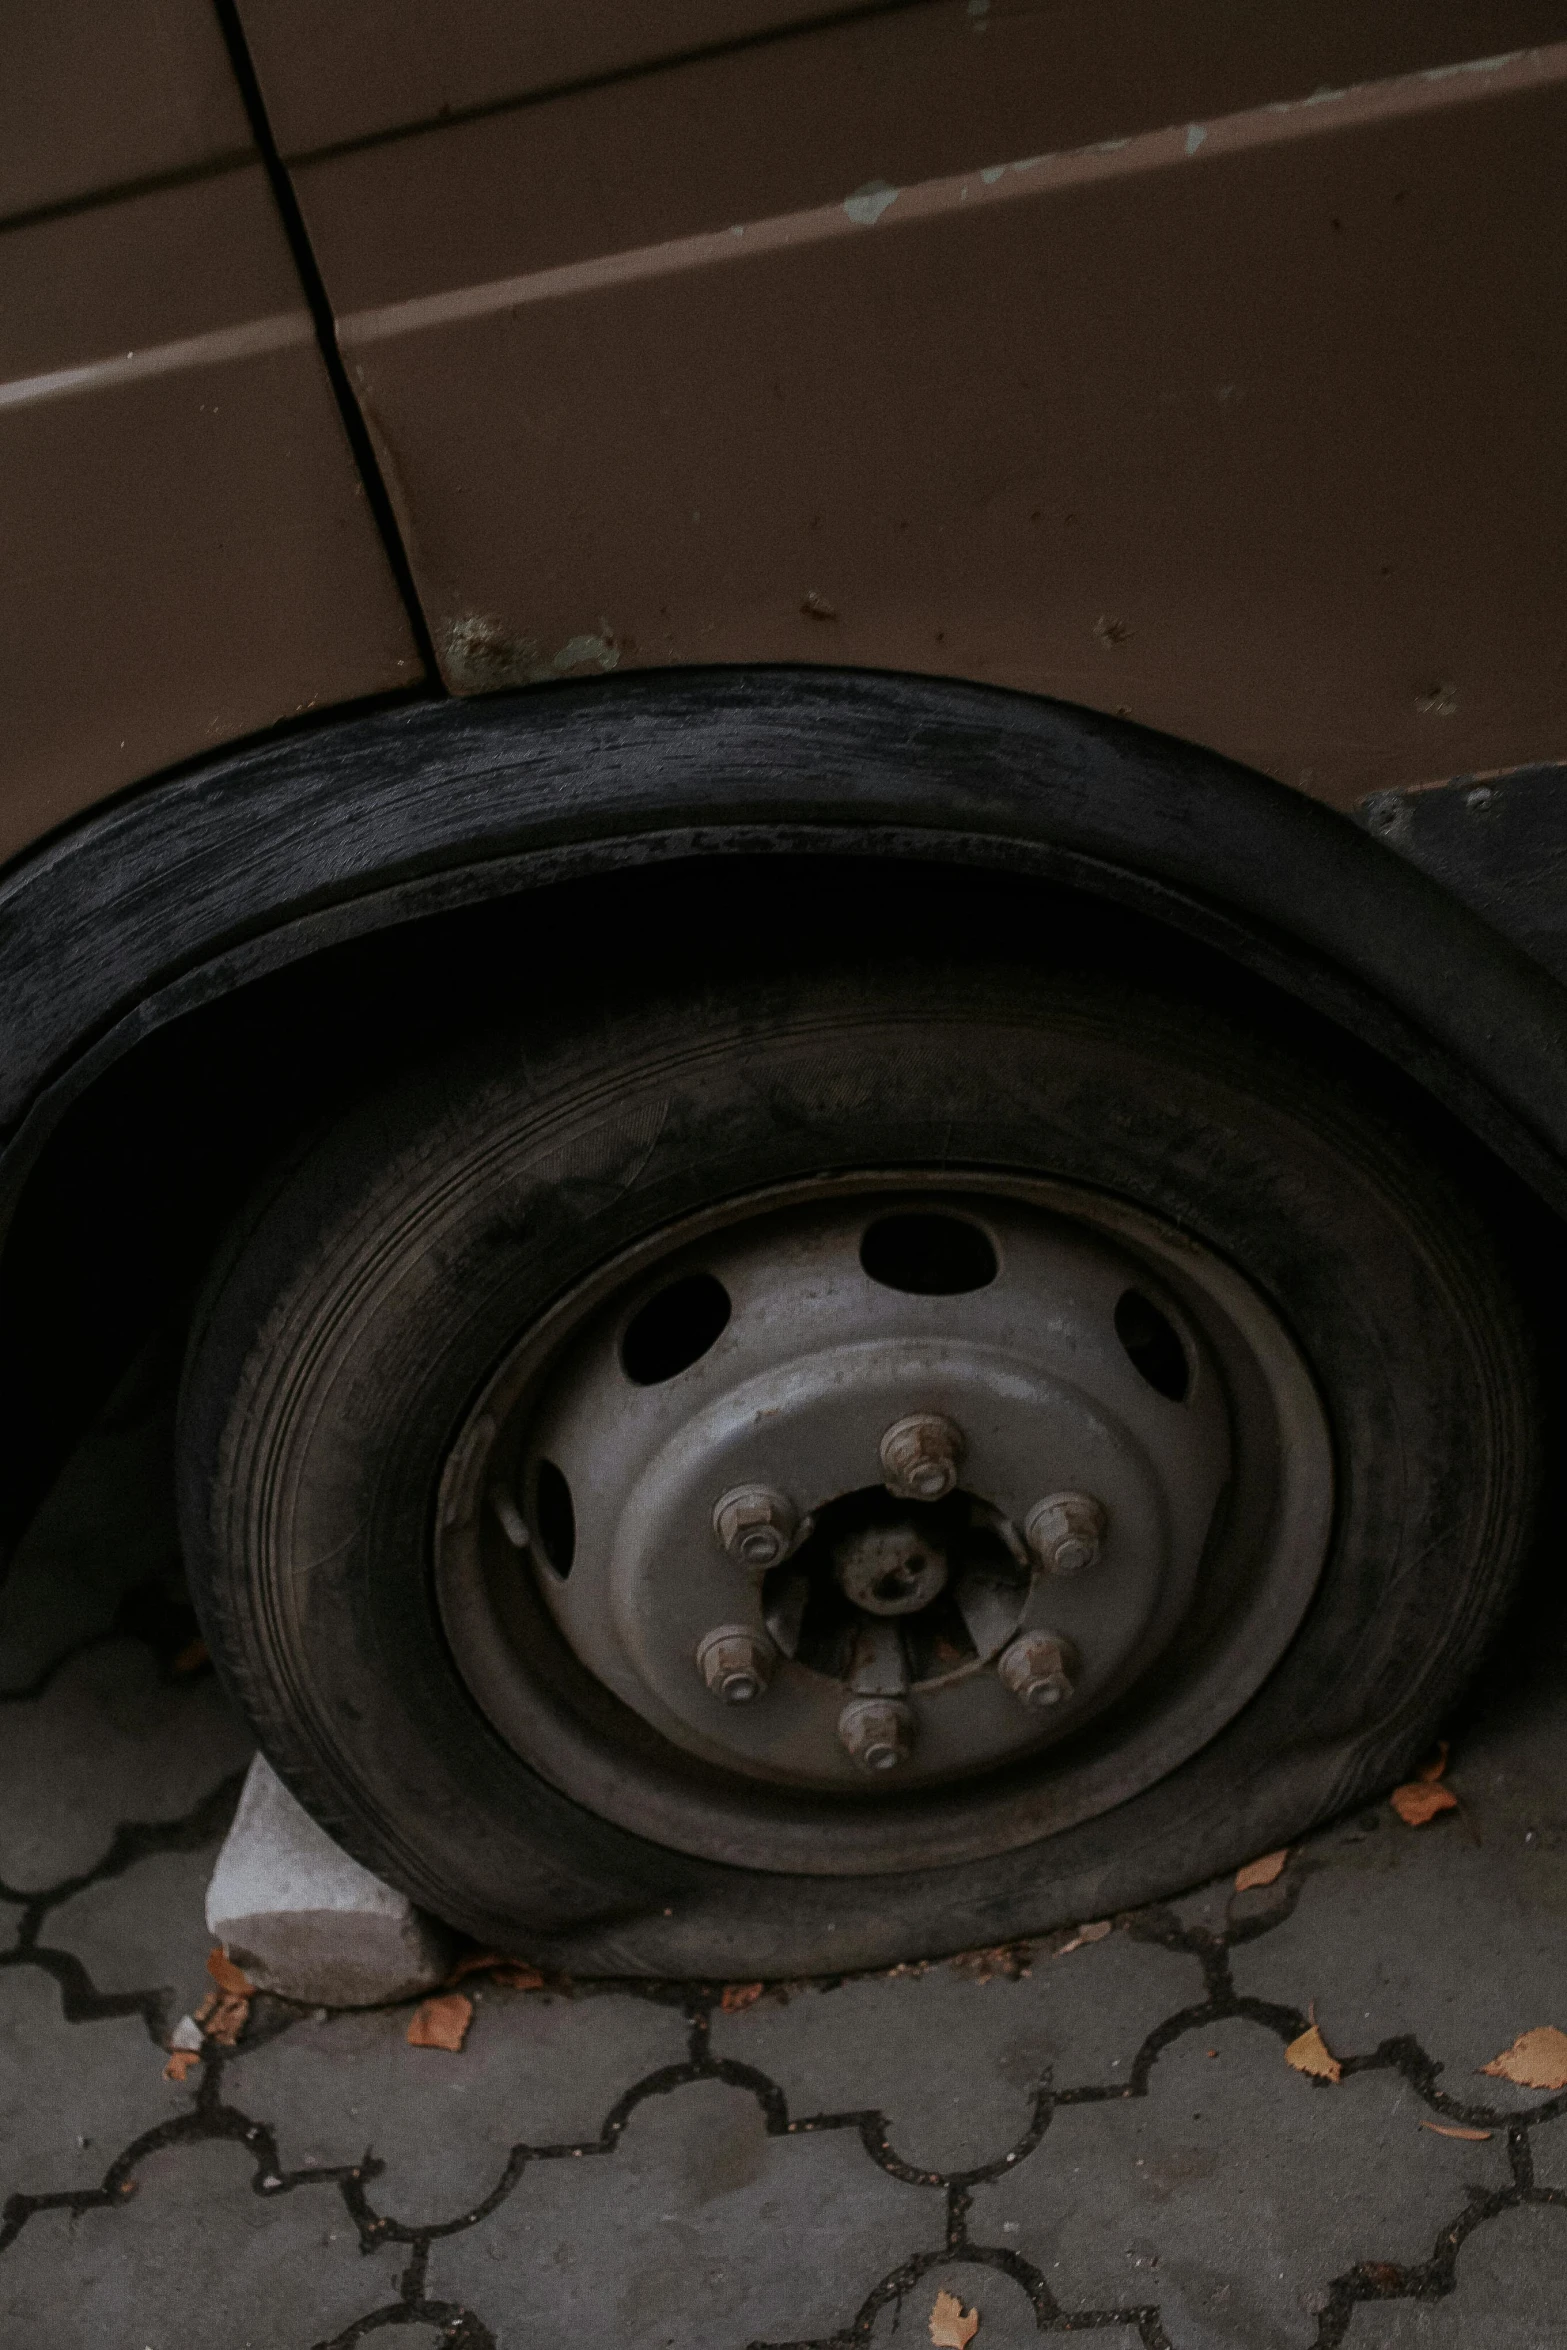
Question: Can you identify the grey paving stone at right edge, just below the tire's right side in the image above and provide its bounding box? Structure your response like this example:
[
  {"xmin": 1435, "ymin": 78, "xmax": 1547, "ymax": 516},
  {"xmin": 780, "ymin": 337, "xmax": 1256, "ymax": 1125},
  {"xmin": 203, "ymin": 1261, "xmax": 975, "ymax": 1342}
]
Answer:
[{"xmin": 1233, "ymin": 1770, "xmax": 1567, "ymax": 2110}]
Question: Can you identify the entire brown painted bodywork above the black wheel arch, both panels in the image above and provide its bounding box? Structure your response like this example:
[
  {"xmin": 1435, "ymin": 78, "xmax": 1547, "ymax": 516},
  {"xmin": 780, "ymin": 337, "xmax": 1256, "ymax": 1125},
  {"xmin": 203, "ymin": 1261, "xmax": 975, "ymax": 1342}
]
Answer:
[{"xmin": 0, "ymin": 0, "xmax": 1567, "ymax": 855}]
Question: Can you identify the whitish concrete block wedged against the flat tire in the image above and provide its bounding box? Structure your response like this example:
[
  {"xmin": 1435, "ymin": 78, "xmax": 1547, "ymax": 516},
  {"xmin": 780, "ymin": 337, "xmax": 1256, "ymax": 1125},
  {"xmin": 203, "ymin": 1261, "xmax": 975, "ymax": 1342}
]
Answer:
[{"xmin": 207, "ymin": 1755, "xmax": 456, "ymax": 2007}]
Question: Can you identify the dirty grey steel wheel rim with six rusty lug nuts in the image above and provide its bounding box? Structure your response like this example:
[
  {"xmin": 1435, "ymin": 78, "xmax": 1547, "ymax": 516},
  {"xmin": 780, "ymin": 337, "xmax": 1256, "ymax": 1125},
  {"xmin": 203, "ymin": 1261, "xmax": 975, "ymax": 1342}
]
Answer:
[{"xmin": 435, "ymin": 1175, "xmax": 1332, "ymax": 1875}]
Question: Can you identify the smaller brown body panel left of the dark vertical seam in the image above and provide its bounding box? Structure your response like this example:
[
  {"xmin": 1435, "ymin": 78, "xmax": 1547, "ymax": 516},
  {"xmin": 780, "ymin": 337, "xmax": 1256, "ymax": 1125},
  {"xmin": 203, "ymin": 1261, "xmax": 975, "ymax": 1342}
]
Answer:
[{"xmin": 0, "ymin": 5, "xmax": 418, "ymax": 858}]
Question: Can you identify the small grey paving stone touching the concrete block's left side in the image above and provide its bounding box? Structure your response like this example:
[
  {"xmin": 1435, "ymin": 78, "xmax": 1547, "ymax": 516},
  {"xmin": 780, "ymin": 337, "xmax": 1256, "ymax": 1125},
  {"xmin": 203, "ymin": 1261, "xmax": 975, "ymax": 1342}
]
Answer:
[{"xmin": 40, "ymin": 1838, "xmax": 218, "ymax": 2016}]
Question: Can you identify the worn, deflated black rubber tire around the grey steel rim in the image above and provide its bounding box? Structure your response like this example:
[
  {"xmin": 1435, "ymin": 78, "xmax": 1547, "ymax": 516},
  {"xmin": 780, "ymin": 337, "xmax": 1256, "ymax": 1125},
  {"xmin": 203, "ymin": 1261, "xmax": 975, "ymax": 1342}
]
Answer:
[{"xmin": 181, "ymin": 935, "xmax": 1541, "ymax": 1976}]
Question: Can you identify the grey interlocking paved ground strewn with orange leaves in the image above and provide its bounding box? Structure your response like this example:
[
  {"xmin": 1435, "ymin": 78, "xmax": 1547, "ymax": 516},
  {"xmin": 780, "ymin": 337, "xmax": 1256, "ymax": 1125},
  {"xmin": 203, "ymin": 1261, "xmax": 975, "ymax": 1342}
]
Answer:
[{"xmin": 0, "ymin": 1394, "xmax": 1567, "ymax": 2350}]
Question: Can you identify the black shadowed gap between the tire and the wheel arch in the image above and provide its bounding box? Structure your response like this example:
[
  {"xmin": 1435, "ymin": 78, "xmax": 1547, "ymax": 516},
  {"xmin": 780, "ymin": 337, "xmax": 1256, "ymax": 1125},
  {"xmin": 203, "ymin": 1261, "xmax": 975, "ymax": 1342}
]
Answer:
[{"xmin": 0, "ymin": 853, "xmax": 1553, "ymax": 1544}]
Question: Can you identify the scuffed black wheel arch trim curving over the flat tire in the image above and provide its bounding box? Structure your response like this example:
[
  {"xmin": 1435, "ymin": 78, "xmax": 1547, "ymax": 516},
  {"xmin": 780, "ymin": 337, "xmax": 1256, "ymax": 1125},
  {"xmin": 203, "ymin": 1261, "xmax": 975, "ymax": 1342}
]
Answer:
[{"xmin": 0, "ymin": 670, "xmax": 1567, "ymax": 1560}]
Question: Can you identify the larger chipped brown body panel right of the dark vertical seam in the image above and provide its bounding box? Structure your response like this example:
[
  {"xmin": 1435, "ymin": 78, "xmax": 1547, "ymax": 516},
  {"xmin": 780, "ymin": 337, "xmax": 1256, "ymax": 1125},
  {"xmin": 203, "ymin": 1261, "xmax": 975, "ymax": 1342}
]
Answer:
[{"xmin": 263, "ymin": 0, "xmax": 1567, "ymax": 804}]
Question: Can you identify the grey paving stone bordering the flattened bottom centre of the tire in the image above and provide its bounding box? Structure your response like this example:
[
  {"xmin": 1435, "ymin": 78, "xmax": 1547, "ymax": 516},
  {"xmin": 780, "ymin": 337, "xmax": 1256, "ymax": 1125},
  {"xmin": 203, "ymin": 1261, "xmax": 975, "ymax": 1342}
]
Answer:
[{"xmin": 712, "ymin": 1932, "xmax": 1203, "ymax": 2169}]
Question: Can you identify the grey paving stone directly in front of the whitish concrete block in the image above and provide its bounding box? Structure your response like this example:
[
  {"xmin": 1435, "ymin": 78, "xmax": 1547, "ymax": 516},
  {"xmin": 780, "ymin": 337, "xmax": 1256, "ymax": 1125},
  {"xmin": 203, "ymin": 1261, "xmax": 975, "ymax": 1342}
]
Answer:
[{"xmin": 226, "ymin": 1981, "xmax": 686, "ymax": 2225}]
